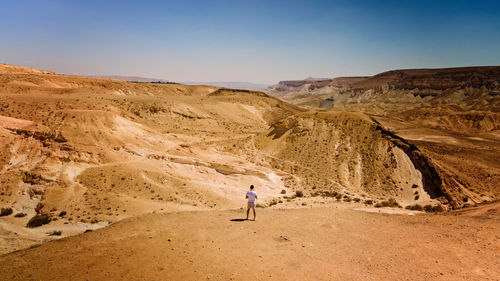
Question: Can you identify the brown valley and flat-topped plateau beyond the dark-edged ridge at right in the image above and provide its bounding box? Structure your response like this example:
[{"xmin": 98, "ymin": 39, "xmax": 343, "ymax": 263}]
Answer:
[{"xmin": 268, "ymin": 66, "xmax": 500, "ymax": 210}]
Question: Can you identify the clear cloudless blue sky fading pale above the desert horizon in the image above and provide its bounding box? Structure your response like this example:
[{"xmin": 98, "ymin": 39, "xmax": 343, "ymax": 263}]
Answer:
[{"xmin": 0, "ymin": 0, "xmax": 500, "ymax": 84}]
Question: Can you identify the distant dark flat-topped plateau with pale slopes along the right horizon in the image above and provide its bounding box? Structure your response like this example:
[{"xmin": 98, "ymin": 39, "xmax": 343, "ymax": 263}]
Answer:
[{"xmin": 267, "ymin": 66, "xmax": 500, "ymax": 109}]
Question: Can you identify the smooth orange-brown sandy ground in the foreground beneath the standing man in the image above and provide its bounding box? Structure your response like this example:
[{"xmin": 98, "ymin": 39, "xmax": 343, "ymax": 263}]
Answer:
[{"xmin": 0, "ymin": 204, "xmax": 500, "ymax": 280}]
